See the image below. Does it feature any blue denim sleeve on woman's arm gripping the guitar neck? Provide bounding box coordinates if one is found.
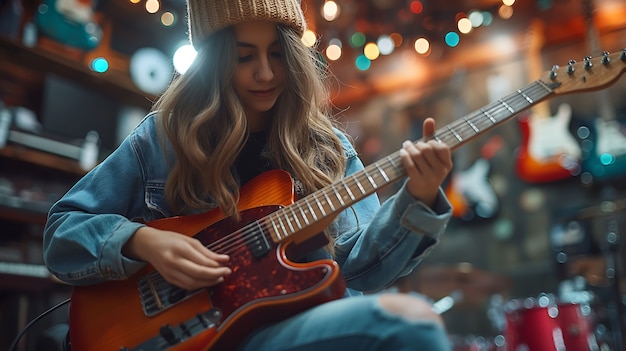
[332,134,452,291]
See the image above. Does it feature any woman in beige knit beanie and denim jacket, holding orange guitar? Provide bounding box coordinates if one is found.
[44,0,452,351]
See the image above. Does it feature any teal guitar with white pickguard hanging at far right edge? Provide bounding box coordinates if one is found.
[577,0,626,185]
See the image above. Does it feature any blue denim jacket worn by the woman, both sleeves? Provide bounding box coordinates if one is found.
[44,113,452,294]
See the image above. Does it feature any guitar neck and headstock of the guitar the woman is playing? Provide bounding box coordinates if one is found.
[255,48,626,243]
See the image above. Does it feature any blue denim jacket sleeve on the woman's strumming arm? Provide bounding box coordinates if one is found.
[43,115,159,285]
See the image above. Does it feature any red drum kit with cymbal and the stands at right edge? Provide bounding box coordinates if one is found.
[400,200,626,351]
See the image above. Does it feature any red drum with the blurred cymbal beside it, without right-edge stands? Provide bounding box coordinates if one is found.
[410,263,608,351]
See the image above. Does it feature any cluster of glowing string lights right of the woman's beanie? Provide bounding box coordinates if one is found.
[303,0,515,71]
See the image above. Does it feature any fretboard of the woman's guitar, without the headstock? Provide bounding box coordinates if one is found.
[262,80,554,242]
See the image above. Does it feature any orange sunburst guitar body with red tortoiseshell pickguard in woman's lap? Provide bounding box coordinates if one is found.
[70,171,345,351]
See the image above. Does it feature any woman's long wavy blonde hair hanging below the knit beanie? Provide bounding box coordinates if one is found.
[154,25,345,220]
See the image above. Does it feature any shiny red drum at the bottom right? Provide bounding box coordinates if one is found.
[504,295,599,351]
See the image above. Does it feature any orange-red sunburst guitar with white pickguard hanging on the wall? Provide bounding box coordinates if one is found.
[516,20,581,183]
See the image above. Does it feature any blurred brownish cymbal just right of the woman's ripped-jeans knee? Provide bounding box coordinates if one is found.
[411,262,511,303]
